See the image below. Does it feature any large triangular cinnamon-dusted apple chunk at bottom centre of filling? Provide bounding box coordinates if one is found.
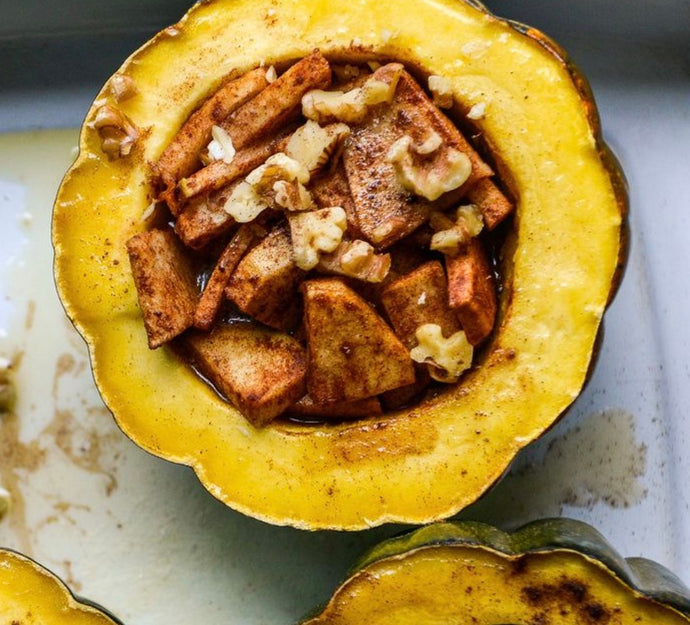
[302,278,415,403]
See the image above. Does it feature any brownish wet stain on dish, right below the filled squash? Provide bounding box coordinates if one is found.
[470,408,647,518]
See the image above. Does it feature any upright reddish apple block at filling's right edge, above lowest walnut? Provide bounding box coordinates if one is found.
[445,239,497,345]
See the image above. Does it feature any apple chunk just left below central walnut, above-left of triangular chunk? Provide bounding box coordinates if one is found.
[225,226,305,330]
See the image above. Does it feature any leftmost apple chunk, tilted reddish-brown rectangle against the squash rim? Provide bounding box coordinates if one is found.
[127,229,198,349]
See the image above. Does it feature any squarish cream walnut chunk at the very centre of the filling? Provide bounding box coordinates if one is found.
[288,206,347,271]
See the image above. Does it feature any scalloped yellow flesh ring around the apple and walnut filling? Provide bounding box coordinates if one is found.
[53,0,626,530]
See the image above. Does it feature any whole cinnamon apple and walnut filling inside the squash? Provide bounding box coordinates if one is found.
[127,51,512,426]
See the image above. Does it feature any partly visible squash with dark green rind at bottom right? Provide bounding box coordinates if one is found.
[303,519,690,625]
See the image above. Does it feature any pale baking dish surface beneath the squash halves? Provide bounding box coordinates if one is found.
[0,0,690,625]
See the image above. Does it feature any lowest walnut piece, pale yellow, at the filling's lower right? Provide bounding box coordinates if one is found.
[410,323,474,383]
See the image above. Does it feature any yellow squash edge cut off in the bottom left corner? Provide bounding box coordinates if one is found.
[0,549,120,625]
